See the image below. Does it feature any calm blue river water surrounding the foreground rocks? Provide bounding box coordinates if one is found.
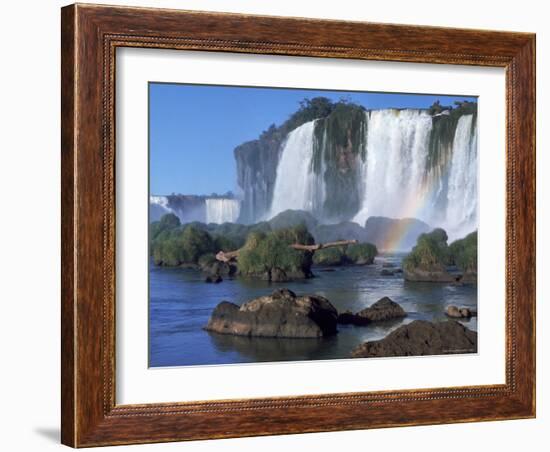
[149,254,477,367]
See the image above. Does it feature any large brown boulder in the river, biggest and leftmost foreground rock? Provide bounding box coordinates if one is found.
[205,289,338,338]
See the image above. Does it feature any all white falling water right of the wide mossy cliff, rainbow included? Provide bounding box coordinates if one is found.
[354,110,477,240]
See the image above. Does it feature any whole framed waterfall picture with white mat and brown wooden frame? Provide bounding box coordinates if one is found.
[61,4,535,447]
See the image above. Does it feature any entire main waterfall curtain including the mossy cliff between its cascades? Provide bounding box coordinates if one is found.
[256,109,478,240]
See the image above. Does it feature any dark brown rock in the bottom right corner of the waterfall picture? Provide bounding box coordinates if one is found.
[352,320,477,358]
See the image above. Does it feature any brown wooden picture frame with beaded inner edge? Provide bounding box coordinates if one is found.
[61,4,535,447]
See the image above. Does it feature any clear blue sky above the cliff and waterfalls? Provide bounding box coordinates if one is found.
[149,83,472,195]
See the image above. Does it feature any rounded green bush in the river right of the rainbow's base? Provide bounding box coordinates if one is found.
[403,228,449,271]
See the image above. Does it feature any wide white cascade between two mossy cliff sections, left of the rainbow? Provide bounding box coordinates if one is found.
[354,110,432,224]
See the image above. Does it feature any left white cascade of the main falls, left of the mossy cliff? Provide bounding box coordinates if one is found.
[268,121,322,218]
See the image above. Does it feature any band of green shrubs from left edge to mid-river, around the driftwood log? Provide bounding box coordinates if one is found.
[150,211,378,278]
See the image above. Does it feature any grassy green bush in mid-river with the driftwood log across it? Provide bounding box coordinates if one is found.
[239,226,314,277]
